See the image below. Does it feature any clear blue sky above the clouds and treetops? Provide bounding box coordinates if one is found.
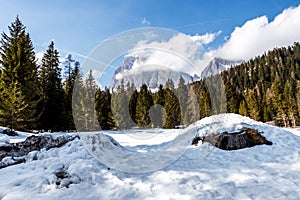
[0,0,300,59]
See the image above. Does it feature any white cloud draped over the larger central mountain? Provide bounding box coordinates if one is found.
[127,31,221,75]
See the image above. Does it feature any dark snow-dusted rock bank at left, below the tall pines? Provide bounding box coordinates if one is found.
[0,136,78,169]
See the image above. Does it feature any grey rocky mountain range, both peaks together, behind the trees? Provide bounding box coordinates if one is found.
[110,56,242,89]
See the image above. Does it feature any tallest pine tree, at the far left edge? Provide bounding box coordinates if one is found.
[0,17,41,130]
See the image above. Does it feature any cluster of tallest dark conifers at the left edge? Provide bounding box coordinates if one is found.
[0,17,79,131]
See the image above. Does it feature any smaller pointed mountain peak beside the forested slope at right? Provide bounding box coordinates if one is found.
[201,58,242,78]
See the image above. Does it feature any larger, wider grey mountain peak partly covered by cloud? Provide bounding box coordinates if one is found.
[110,56,199,89]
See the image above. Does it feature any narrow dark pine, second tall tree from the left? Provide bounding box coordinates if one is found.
[40,42,64,131]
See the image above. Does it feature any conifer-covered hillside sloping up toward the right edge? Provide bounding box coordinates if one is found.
[194,43,300,126]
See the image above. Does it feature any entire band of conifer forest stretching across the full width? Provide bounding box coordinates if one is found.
[0,17,300,131]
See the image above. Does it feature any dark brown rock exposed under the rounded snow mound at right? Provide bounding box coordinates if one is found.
[192,128,272,150]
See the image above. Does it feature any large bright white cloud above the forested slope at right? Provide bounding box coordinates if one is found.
[209,5,300,60]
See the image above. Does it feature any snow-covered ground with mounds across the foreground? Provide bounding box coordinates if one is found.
[0,114,300,200]
